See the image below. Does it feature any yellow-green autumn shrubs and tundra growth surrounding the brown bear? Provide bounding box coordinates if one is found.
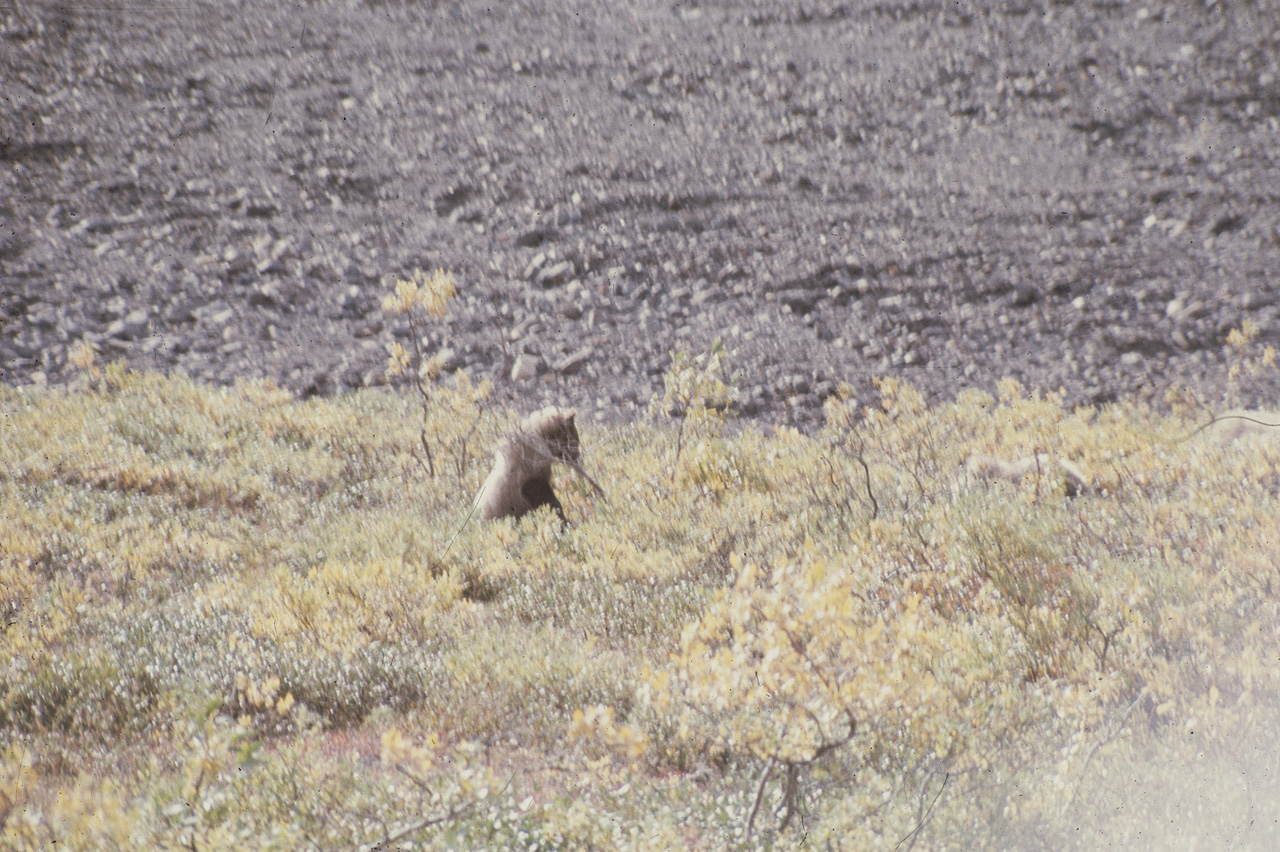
[0,281,1280,851]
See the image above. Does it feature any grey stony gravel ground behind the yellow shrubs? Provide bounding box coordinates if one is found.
[0,0,1280,429]
